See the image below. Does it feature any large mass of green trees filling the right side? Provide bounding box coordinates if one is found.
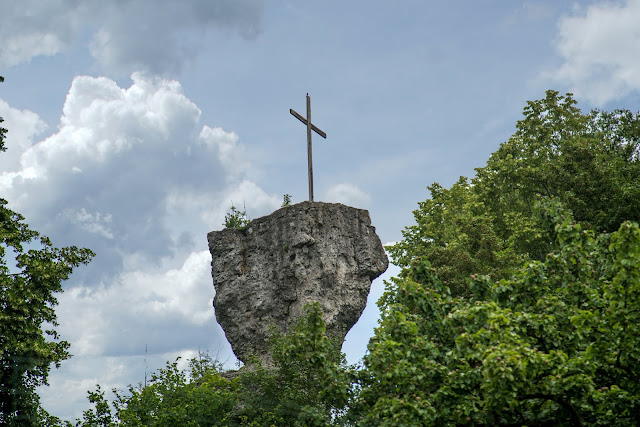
[358,91,640,425]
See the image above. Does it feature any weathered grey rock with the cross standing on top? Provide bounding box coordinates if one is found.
[207,202,389,362]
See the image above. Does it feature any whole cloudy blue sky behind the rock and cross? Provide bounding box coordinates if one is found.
[0,0,640,419]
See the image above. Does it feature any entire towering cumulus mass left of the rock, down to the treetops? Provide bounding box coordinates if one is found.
[0,73,280,415]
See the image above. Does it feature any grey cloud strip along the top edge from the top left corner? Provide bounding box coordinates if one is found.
[0,0,264,73]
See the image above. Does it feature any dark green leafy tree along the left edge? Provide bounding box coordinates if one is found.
[0,78,93,425]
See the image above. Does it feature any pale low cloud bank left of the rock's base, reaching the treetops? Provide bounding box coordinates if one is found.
[39,251,237,419]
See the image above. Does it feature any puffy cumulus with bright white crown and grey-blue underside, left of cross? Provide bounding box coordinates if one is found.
[0,73,279,281]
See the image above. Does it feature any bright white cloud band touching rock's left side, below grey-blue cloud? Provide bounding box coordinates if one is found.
[57,250,216,356]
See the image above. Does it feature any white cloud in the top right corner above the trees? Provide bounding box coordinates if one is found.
[544,0,640,105]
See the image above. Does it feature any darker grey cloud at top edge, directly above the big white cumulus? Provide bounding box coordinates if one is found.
[91,0,263,72]
